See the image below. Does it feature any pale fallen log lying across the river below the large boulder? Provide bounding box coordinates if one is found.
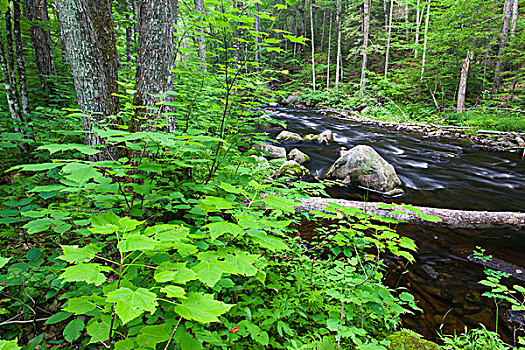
[295,197,525,230]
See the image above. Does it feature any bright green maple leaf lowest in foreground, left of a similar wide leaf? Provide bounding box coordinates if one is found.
[106,287,157,324]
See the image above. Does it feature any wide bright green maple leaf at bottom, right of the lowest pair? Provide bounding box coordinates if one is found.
[175,293,233,323]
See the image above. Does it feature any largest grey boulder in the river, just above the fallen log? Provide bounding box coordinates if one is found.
[323,145,402,195]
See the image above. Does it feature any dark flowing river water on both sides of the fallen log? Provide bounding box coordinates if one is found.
[267,108,525,342]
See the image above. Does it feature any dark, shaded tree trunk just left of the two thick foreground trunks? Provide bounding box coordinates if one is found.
[26,0,57,92]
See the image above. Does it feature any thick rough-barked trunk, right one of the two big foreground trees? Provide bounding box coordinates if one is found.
[134,0,175,131]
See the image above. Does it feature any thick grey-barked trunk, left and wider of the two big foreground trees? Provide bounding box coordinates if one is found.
[55,0,119,153]
